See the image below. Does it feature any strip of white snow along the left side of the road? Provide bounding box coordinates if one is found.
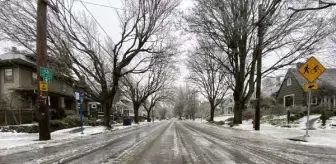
[0,122,158,149]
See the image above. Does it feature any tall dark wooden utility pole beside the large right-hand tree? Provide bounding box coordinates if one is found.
[254,5,266,130]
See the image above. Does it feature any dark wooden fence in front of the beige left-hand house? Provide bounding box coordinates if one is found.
[0,109,35,125]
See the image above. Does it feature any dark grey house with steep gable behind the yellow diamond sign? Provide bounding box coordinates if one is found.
[276,63,336,109]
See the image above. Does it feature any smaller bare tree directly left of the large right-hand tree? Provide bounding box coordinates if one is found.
[187,47,230,121]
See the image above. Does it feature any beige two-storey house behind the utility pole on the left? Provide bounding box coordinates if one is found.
[0,49,76,110]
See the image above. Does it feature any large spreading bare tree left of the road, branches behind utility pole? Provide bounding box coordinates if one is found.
[0,0,180,127]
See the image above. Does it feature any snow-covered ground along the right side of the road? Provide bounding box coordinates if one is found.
[225,115,336,147]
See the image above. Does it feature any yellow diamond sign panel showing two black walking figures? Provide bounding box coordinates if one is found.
[299,56,326,82]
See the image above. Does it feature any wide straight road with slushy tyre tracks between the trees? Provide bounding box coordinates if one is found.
[0,120,336,164]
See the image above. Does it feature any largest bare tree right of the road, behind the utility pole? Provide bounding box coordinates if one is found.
[186,0,331,124]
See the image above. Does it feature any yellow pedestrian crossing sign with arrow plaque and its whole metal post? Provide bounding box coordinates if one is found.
[299,56,326,137]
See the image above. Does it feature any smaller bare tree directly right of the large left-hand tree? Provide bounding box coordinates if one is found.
[122,60,175,123]
